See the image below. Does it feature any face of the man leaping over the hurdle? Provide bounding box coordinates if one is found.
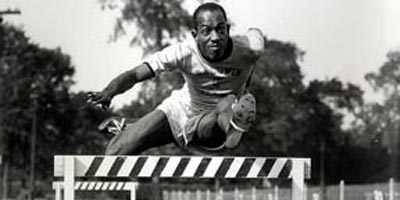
[193,10,229,62]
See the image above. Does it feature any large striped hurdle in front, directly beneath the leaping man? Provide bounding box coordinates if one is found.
[54,155,311,200]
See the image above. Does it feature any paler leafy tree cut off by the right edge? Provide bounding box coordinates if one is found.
[361,50,400,178]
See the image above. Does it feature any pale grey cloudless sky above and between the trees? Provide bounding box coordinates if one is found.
[0,0,400,107]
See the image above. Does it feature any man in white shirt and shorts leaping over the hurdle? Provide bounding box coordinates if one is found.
[88,3,264,155]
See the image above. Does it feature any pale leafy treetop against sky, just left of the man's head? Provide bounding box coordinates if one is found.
[100,0,191,53]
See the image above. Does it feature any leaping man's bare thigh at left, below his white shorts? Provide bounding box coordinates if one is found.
[106,110,173,155]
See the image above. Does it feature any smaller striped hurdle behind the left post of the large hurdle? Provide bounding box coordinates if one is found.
[53,181,137,200]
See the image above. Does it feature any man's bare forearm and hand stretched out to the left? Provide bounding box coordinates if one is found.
[87,63,155,109]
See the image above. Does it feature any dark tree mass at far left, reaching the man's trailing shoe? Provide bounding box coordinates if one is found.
[0,24,109,198]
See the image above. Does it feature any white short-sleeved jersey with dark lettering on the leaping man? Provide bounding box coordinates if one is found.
[144,29,264,114]
